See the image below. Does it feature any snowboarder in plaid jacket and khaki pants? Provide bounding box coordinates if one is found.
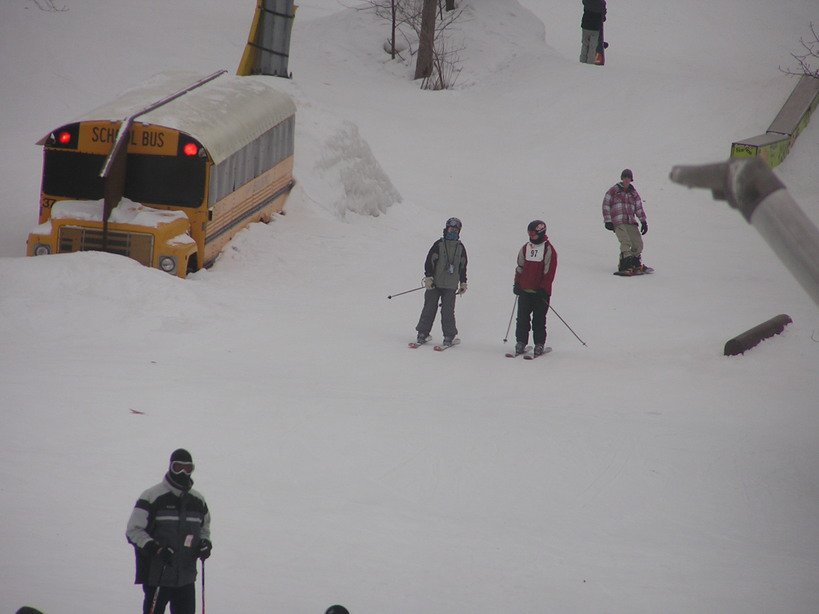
[603,168,649,274]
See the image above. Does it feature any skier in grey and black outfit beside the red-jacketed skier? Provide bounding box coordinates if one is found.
[415,217,466,347]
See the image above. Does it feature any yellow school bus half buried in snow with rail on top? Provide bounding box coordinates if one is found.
[27,71,296,277]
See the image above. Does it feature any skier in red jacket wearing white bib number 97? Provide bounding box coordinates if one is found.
[512,220,557,356]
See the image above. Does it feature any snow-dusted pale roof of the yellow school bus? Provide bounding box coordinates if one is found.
[37,71,296,164]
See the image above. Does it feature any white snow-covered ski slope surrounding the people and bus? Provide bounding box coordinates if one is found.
[0,0,819,614]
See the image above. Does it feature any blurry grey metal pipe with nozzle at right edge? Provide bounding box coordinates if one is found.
[670,158,819,307]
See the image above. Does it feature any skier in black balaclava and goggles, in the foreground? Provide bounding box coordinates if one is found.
[125,448,213,614]
